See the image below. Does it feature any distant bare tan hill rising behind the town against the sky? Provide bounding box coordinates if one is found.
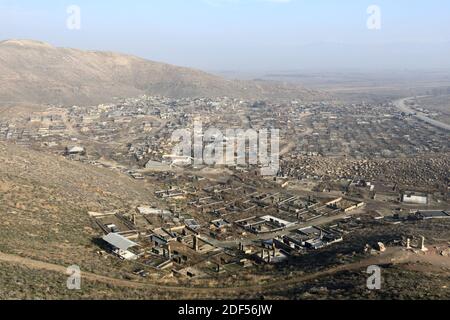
[0,40,313,104]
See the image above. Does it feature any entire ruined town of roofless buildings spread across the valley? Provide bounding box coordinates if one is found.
[0,96,450,279]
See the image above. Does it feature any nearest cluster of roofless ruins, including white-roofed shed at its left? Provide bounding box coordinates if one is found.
[89,171,450,279]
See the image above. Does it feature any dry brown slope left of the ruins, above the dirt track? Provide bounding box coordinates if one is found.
[0,143,156,268]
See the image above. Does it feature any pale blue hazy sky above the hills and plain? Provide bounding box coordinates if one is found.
[0,0,450,72]
